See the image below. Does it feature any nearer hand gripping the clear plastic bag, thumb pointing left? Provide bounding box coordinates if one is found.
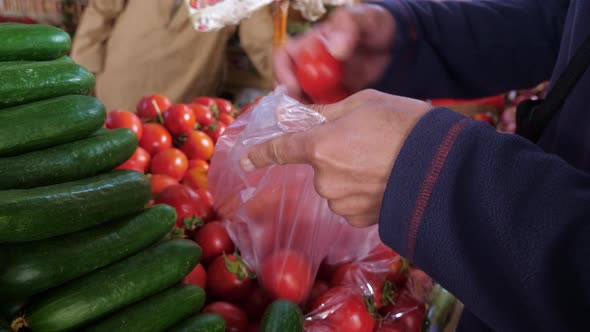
[240,90,432,227]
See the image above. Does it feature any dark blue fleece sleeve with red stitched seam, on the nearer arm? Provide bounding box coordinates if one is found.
[379,108,590,331]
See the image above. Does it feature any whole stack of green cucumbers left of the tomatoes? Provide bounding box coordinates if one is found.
[0,23,225,332]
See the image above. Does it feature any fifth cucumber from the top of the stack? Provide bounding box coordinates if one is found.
[0,170,151,243]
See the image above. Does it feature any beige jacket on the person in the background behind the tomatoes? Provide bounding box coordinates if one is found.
[72,0,272,111]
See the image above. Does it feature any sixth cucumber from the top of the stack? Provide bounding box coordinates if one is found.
[0,205,176,296]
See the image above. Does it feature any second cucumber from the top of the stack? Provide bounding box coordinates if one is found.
[0,61,95,108]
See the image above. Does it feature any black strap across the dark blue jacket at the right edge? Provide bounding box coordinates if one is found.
[516,35,590,142]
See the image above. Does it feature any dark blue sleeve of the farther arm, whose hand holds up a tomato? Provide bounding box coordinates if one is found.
[374,0,569,99]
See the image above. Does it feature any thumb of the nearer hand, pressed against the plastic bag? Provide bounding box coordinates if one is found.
[240,131,310,172]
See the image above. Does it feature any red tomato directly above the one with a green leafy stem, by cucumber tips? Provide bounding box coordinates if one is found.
[194,221,234,263]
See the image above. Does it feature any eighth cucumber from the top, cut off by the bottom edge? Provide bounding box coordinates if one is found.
[82,285,205,332]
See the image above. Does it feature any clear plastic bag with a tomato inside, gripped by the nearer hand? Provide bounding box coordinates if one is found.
[209,88,366,303]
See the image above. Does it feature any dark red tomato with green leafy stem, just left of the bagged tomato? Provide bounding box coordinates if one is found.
[207,254,254,303]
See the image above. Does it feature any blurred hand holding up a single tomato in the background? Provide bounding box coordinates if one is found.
[273,4,395,102]
